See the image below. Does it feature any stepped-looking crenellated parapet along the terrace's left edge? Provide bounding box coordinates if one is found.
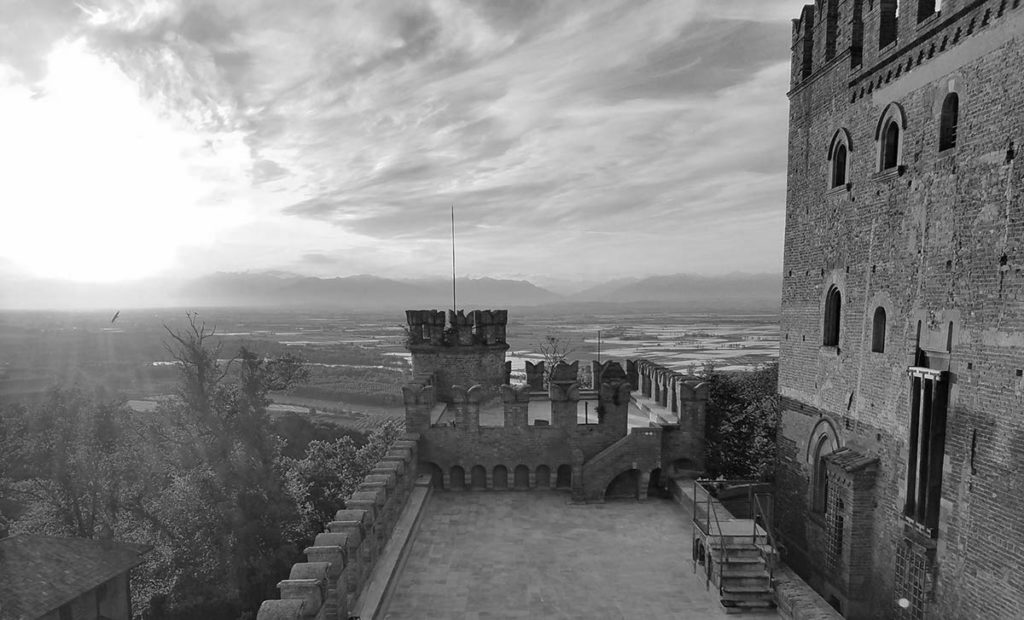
[257,433,428,620]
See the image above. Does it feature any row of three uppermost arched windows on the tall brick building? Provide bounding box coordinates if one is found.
[828,92,959,188]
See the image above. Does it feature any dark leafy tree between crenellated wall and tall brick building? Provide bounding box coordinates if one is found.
[702,362,779,481]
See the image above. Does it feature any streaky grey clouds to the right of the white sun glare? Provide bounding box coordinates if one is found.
[0,0,803,275]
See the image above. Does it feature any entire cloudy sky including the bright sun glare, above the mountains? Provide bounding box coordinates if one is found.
[0,0,805,283]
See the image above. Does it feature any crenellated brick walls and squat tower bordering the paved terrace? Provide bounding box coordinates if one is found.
[258,311,737,620]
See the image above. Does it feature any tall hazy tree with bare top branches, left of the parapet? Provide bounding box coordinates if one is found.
[132,315,304,617]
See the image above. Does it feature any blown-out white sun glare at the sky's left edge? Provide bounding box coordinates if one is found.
[0,41,237,282]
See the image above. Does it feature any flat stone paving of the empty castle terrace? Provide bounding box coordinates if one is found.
[380,491,775,620]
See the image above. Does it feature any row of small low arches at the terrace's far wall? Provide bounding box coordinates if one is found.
[419,463,572,491]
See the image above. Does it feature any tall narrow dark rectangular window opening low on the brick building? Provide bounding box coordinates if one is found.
[903,366,948,538]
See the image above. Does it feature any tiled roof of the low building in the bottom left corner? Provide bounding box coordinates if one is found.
[0,535,153,620]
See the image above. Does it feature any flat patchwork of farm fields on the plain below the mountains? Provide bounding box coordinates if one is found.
[0,307,778,429]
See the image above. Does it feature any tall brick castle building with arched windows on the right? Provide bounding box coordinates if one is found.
[776,0,1024,619]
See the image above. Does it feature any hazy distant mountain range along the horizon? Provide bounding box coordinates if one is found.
[0,273,781,309]
